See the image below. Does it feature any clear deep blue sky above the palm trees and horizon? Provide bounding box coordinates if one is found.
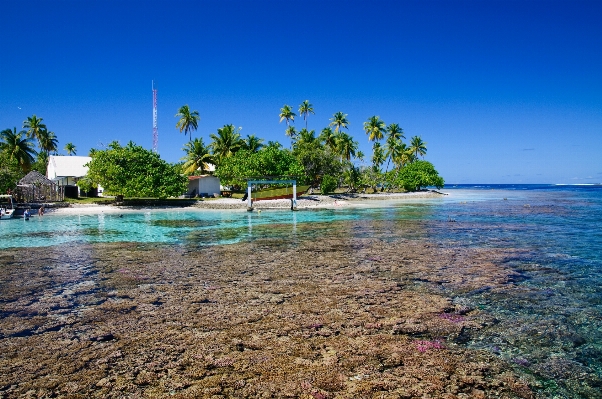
[0,0,602,183]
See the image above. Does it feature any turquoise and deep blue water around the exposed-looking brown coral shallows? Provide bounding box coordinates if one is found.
[0,184,602,398]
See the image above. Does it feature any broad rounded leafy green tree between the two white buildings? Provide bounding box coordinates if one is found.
[87,141,187,198]
